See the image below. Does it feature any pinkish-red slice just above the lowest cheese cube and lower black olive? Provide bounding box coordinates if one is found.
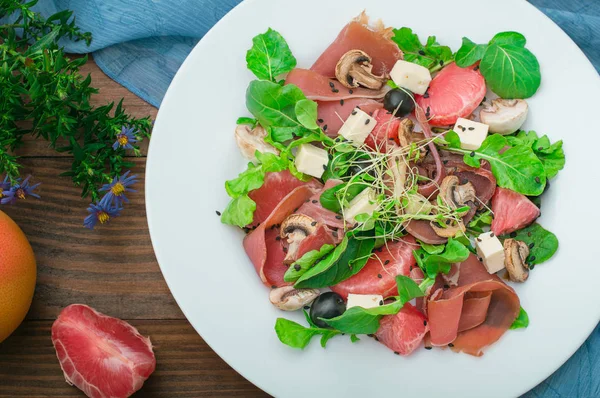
[331,236,417,298]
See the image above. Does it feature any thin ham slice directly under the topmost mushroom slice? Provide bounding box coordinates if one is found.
[285,68,390,102]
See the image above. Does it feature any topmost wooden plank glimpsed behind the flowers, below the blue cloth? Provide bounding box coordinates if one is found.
[15,54,158,157]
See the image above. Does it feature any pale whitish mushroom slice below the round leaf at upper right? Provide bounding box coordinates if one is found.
[479,98,529,135]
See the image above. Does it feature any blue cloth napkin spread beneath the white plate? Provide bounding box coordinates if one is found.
[31,0,600,398]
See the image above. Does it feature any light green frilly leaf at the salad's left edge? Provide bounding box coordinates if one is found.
[221,151,290,228]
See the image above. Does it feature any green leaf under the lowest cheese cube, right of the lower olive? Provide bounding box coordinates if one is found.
[321,275,424,334]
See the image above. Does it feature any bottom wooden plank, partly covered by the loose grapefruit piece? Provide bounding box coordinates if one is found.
[0,320,268,397]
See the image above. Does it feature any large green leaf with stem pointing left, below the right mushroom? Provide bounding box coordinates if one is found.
[448,134,546,196]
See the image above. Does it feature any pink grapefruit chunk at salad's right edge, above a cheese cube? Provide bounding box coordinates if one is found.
[492,187,540,236]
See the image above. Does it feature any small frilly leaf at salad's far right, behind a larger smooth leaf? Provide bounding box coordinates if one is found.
[506,131,565,178]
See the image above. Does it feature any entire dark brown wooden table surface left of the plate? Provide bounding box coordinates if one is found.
[0,60,266,397]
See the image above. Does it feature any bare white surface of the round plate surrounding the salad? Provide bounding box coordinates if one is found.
[146,0,600,397]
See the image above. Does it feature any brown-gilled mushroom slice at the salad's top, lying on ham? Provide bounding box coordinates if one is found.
[335,50,388,90]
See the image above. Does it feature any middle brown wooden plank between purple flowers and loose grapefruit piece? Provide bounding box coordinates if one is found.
[2,158,184,319]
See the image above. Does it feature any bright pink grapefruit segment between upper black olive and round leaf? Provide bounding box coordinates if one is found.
[415,63,486,127]
